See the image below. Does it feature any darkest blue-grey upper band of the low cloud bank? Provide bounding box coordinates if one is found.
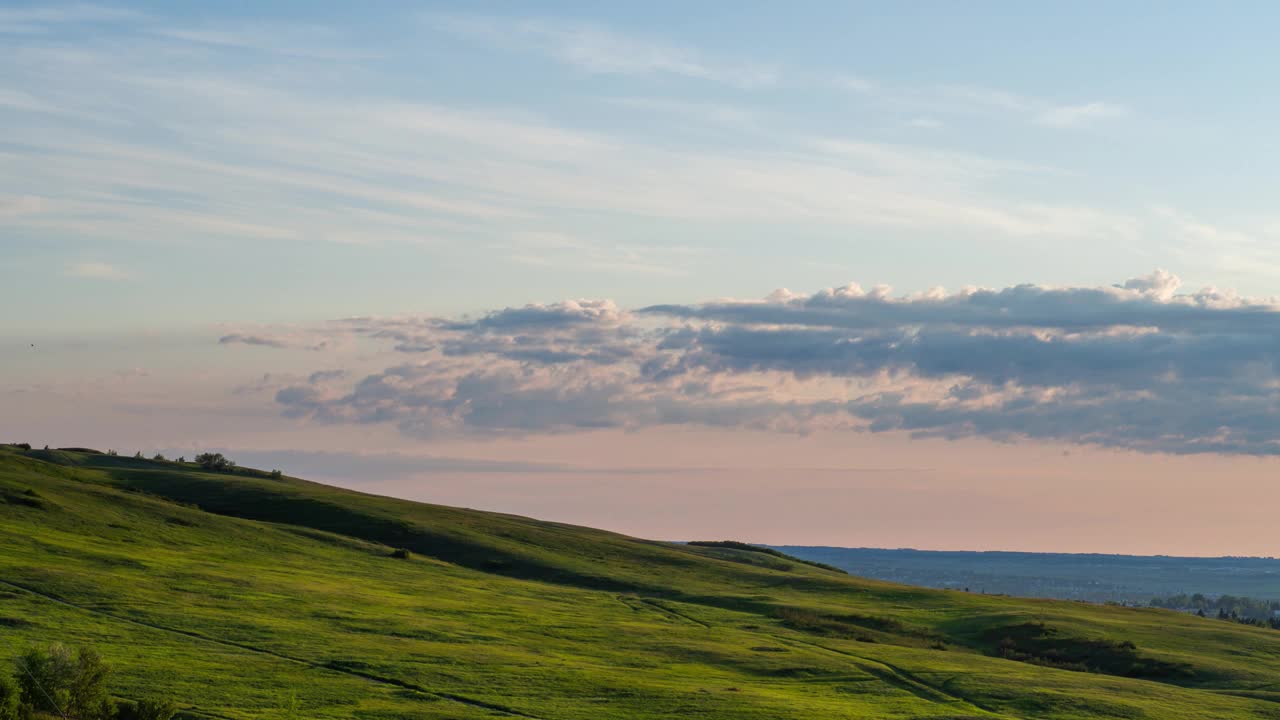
[648,320,1280,389]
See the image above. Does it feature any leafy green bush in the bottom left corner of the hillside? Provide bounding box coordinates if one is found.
[17,644,114,720]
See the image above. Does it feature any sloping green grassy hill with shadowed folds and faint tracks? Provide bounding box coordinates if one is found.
[0,446,1280,720]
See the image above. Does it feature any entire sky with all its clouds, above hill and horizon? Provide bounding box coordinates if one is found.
[0,1,1280,555]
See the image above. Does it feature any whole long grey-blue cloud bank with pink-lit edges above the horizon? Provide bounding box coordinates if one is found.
[264,270,1280,455]
